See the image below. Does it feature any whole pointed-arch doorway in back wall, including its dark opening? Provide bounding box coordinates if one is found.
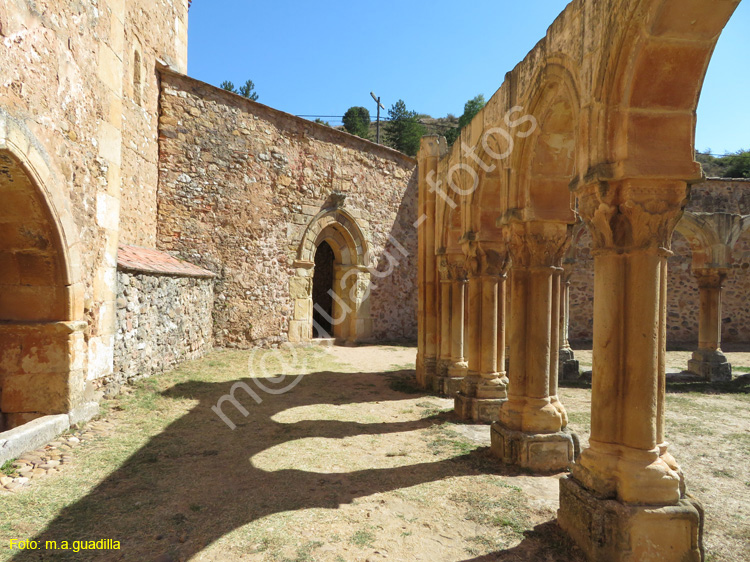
[289,207,372,344]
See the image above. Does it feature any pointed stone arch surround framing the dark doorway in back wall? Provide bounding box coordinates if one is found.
[289,207,373,343]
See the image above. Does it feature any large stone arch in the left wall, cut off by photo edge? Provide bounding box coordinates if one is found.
[0,120,86,428]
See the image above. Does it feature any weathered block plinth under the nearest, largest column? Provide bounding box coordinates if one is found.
[557,476,703,562]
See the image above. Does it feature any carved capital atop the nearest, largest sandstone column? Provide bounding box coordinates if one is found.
[576,178,687,252]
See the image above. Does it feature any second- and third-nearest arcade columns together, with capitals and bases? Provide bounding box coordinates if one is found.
[455,221,575,472]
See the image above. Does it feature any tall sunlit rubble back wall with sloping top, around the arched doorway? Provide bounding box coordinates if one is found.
[158,72,417,346]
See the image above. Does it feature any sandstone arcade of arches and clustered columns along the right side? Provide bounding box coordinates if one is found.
[417,0,743,562]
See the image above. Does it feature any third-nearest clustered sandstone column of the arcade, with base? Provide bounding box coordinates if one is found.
[455,235,508,422]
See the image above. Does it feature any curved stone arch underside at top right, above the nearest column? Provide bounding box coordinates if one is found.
[590,0,740,180]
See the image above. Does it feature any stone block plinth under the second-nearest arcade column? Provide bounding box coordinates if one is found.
[490,423,580,474]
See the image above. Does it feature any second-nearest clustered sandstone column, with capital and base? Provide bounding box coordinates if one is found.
[491,221,574,472]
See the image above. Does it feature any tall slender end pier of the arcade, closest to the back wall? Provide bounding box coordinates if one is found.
[417,135,444,388]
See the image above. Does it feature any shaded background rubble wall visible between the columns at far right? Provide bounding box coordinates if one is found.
[570,179,750,349]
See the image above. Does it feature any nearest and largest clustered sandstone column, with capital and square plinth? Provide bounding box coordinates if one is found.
[558,180,701,561]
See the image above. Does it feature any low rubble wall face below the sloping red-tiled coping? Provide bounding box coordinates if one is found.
[112,271,214,384]
